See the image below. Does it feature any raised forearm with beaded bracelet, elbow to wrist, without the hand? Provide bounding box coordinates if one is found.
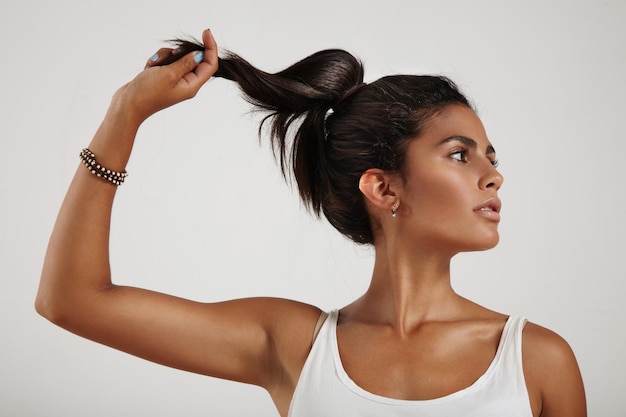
[36,99,139,322]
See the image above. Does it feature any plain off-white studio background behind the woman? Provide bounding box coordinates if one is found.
[0,0,626,417]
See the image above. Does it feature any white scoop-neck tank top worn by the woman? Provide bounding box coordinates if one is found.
[289,310,532,417]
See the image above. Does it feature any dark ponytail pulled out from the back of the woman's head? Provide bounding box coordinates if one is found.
[216,49,363,215]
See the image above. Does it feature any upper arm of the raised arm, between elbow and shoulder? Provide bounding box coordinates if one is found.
[45,286,319,387]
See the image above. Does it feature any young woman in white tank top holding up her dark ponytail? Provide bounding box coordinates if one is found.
[36,30,586,417]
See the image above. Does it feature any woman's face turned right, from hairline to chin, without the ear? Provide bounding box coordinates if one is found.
[398,105,503,254]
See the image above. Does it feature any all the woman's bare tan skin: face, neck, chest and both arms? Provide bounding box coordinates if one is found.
[36,31,586,417]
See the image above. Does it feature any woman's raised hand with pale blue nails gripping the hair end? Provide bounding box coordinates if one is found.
[113,29,218,125]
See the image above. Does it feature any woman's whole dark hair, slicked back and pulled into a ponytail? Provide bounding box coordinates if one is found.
[162,40,471,243]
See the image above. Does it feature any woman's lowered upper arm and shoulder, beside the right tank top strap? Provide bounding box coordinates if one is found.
[522,323,587,417]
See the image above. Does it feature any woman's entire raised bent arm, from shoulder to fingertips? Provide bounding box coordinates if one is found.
[36,30,319,404]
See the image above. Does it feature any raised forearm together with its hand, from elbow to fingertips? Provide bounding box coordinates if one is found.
[36,30,218,333]
